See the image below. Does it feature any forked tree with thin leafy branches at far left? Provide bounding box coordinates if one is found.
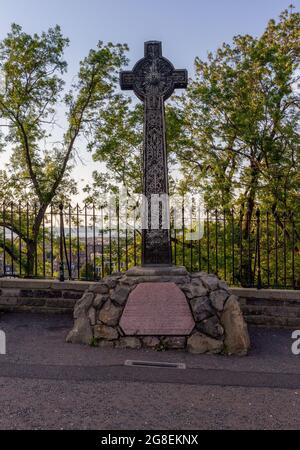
[0,24,127,275]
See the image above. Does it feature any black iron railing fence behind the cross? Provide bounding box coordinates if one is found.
[0,200,300,289]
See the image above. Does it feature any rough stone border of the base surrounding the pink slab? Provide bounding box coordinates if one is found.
[67,268,250,355]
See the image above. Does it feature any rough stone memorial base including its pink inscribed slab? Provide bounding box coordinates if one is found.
[67,266,250,355]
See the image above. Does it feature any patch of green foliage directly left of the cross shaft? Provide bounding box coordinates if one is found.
[85,95,143,200]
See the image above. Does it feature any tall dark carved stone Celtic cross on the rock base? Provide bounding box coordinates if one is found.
[120,41,188,266]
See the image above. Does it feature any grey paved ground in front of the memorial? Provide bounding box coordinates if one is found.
[0,314,300,430]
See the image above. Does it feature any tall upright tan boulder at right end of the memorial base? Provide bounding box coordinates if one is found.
[221,295,250,356]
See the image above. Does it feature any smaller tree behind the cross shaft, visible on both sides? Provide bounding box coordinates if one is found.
[85,94,188,203]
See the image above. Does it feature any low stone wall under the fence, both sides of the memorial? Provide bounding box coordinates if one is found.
[0,278,300,329]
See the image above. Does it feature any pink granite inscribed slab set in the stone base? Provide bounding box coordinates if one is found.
[120,283,195,336]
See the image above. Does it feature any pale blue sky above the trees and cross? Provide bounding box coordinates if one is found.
[0,0,300,199]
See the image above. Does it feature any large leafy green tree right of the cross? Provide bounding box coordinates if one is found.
[177,7,300,221]
